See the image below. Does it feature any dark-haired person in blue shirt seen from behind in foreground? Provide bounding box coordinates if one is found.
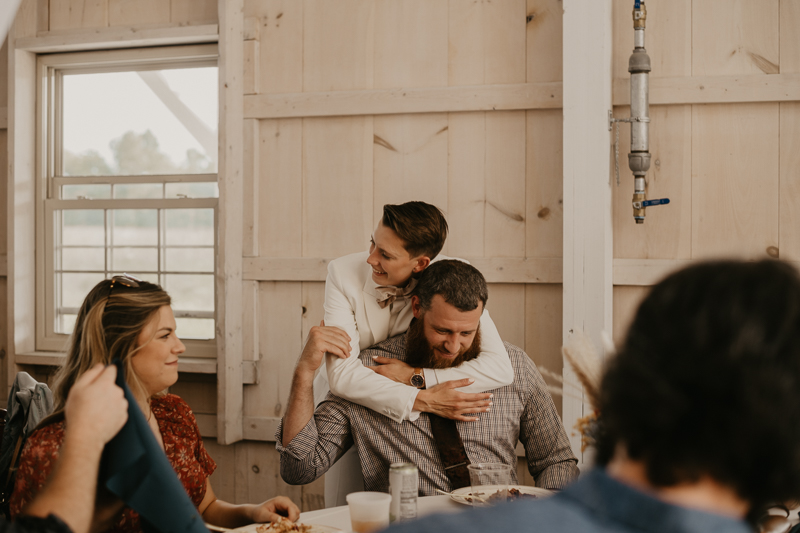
[391,261,800,533]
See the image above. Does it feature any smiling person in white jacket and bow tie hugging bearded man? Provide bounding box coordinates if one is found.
[314,202,514,505]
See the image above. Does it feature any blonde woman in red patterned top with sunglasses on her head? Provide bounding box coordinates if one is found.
[11,276,300,532]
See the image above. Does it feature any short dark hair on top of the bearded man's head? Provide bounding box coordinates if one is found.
[414,259,489,311]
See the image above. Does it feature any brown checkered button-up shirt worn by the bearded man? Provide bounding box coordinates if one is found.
[277,334,578,496]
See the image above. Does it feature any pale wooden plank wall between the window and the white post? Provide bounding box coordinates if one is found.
[244,0,562,490]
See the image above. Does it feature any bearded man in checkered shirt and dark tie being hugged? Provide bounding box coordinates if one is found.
[276,260,578,495]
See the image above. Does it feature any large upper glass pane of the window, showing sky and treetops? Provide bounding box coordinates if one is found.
[63,67,218,176]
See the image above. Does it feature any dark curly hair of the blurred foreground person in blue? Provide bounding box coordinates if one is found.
[597,260,800,506]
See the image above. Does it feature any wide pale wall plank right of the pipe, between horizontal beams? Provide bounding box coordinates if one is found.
[692,104,779,258]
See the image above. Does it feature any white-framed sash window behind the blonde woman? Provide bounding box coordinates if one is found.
[36,45,218,357]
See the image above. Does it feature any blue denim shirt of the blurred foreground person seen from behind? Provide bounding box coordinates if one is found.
[389,469,752,533]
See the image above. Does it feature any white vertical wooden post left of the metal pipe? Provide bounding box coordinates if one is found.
[562,0,612,458]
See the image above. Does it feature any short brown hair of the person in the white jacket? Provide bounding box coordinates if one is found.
[381,202,447,259]
